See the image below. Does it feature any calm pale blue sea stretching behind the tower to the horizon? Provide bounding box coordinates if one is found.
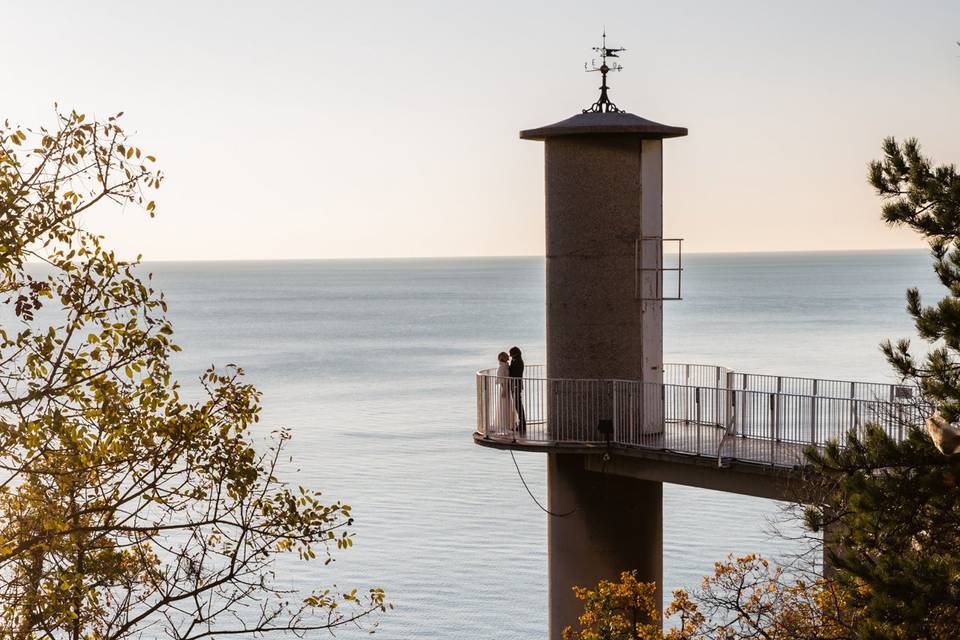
[150,251,936,640]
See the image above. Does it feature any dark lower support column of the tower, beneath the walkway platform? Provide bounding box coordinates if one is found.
[547,453,663,640]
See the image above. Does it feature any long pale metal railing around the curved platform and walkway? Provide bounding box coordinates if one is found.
[477,364,929,467]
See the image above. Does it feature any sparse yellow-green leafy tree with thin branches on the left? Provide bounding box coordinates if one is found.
[0,107,388,640]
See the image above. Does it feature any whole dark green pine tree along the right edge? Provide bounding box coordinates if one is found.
[807,138,960,639]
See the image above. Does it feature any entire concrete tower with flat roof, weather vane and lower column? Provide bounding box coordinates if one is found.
[520,42,687,640]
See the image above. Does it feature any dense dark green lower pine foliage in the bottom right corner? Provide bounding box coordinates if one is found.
[807,426,960,640]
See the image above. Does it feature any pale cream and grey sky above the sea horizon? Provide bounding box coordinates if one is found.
[0,0,960,260]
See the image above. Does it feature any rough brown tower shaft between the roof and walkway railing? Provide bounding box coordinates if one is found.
[545,134,663,382]
